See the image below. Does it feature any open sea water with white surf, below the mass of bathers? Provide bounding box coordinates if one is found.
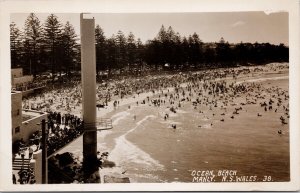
[57,78,290,183]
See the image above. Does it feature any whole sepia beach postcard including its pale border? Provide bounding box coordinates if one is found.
[1,1,299,190]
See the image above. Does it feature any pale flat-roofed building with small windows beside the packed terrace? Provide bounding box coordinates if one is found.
[11,91,47,142]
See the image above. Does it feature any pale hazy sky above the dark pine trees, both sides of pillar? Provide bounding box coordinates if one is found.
[11,12,289,46]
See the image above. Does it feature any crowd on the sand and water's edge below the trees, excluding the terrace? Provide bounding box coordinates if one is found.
[23,63,288,130]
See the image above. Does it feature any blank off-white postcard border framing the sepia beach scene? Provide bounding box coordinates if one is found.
[0,0,300,191]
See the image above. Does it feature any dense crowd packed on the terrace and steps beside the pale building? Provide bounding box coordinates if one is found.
[13,112,83,184]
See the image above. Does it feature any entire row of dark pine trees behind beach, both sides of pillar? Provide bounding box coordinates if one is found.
[10,13,289,77]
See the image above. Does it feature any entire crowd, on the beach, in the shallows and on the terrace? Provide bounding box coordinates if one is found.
[12,64,289,183]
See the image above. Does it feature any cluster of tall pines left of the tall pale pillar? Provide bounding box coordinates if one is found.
[10,13,80,77]
